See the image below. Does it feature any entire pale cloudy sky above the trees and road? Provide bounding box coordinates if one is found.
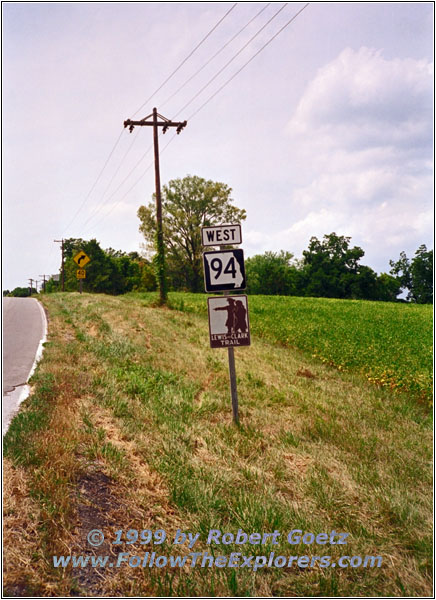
[2,2,434,290]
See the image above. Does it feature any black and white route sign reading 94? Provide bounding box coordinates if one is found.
[203,248,246,292]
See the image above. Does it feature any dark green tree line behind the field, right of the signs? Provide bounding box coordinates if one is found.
[245,238,433,304]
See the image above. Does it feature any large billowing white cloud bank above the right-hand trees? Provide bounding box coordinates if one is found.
[279,48,433,264]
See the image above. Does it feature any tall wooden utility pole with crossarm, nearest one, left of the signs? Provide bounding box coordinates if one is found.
[124,108,188,306]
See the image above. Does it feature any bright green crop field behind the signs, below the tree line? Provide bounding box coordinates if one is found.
[152,293,433,402]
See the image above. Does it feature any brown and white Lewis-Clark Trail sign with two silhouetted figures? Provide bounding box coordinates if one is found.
[207,295,250,348]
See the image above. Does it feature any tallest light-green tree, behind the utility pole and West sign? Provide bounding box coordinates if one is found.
[138,175,246,292]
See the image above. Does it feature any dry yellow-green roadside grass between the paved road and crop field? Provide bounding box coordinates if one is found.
[4,294,432,597]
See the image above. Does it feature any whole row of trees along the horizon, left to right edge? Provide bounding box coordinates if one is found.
[4,175,433,304]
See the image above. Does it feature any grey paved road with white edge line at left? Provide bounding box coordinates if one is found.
[2,298,47,435]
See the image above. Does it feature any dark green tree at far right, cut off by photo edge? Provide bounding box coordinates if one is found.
[389,244,433,304]
